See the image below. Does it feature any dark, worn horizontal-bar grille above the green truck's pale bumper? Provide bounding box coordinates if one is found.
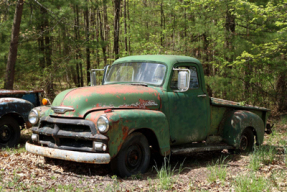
[32,116,108,152]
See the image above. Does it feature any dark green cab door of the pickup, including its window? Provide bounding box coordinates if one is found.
[168,64,210,145]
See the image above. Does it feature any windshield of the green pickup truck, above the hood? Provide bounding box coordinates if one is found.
[105,63,166,85]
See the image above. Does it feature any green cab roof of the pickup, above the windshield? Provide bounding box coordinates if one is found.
[113,55,201,66]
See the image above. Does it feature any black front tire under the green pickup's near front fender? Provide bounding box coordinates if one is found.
[111,133,150,178]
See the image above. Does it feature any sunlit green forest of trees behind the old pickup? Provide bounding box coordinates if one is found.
[0,0,287,112]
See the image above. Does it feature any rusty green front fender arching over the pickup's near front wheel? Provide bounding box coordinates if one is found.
[86,110,170,157]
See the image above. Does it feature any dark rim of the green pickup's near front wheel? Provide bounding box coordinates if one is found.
[126,145,143,171]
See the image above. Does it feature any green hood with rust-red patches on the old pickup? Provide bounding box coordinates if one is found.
[50,84,161,118]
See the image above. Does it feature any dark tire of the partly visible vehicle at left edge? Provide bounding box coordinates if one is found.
[0,117,20,147]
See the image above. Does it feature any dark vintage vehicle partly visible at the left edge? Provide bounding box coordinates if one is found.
[0,89,43,148]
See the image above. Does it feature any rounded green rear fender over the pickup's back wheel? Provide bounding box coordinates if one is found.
[222,110,264,148]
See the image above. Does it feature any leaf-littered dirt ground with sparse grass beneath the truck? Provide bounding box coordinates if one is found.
[0,119,287,192]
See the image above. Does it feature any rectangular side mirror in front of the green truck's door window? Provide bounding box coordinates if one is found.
[173,68,190,92]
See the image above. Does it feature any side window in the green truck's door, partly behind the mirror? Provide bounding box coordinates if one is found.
[170,66,199,89]
